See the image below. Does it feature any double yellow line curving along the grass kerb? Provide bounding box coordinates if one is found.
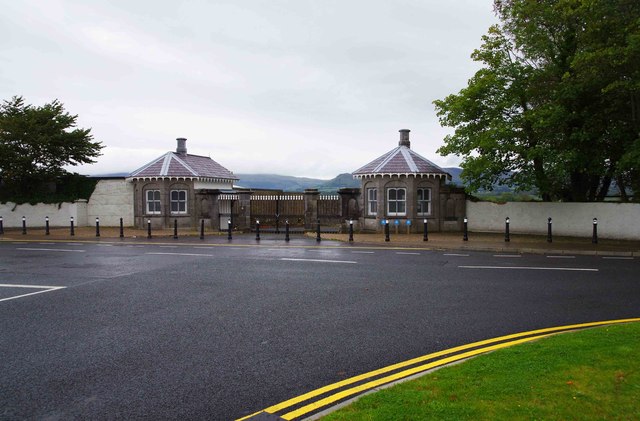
[237,318,640,421]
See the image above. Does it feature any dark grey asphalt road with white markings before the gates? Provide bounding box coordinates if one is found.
[0,239,640,420]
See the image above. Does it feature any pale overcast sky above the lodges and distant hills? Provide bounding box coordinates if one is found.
[0,0,497,179]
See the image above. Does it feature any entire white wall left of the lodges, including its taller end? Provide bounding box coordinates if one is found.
[0,179,133,229]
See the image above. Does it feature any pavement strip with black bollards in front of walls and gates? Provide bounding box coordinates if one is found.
[0,223,640,257]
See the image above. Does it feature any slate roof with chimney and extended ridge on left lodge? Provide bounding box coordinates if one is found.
[128,138,238,182]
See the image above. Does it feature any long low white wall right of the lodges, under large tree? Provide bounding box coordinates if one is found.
[467,200,640,240]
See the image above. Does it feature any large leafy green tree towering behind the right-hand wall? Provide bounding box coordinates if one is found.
[434,0,640,201]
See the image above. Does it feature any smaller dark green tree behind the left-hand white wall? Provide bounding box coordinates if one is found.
[0,96,103,194]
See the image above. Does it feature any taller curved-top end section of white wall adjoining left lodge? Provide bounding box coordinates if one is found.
[87,179,133,227]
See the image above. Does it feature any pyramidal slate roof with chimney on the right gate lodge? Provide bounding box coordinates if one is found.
[353,129,451,180]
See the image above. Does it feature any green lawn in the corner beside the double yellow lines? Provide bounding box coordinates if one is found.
[323,323,640,421]
